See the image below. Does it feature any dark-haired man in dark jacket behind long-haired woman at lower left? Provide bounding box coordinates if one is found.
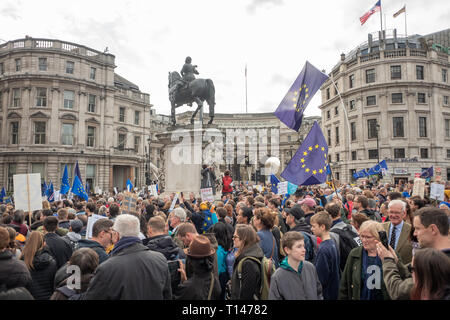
[44,217,72,268]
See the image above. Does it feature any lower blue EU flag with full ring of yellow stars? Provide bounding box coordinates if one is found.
[281,121,328,186]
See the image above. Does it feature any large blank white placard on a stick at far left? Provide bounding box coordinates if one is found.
[13,173,42,212]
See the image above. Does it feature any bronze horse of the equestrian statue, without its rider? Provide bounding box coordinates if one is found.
[169,71,216,125]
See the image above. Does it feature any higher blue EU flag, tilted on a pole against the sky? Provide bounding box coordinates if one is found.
[275,61,329,131]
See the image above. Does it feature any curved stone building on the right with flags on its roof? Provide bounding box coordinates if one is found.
[320,29,450,182]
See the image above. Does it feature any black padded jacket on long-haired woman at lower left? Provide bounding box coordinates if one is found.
[26,248,57,300]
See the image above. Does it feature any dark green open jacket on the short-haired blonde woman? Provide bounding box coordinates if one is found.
[338,246,390,300]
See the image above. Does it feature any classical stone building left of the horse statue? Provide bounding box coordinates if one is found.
[0,37,152,191]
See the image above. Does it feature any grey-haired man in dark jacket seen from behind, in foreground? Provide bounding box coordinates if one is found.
[84,214,172,300]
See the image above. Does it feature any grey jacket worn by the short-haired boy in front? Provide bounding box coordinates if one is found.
[269,261,323,300]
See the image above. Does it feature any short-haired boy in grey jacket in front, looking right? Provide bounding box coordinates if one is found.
[269,231,323,300]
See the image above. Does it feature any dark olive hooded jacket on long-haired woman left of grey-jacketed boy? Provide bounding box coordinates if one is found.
[231,243,264,300]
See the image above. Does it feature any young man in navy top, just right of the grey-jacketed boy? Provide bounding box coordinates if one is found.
[311,211,340,300]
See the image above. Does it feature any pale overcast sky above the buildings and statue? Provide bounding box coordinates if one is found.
[0,0,450,115]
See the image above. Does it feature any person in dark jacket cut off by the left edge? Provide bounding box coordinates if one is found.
[0,227,31,299]
